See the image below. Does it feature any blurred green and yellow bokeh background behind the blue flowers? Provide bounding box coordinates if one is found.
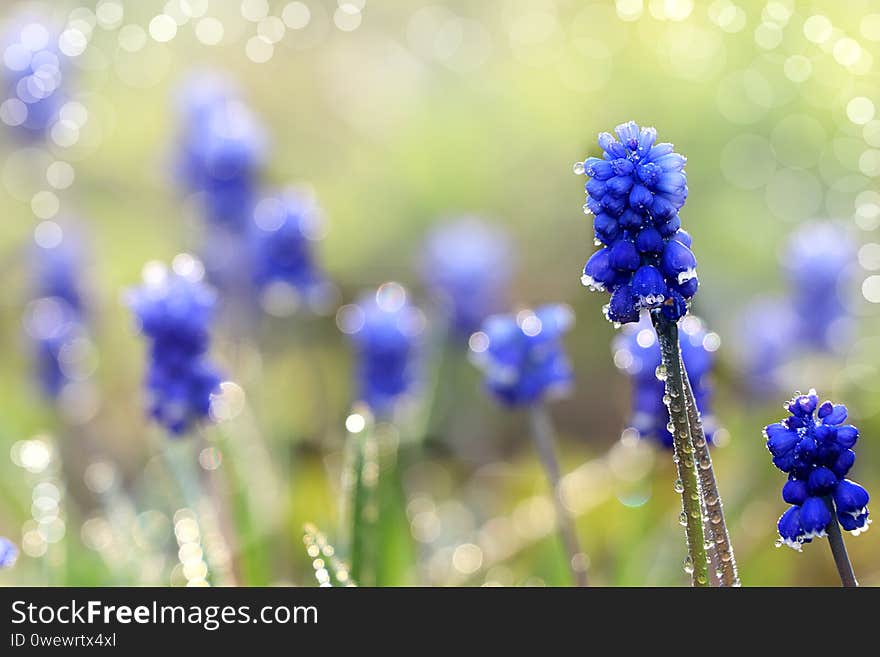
[0,0,880,586]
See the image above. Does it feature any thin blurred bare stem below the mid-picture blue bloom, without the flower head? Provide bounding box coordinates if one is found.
[529,403,588,586]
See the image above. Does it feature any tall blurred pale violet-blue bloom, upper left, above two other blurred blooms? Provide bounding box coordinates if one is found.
[176,74,267,231]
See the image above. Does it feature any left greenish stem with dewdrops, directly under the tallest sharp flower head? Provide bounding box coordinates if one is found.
[651,312,709,586]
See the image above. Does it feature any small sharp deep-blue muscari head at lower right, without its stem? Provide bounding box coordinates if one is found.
[764,390,871,551]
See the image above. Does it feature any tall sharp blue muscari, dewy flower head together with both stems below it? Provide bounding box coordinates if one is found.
[574,121,739,586]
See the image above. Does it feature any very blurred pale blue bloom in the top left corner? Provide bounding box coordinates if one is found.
[0,17,67,139]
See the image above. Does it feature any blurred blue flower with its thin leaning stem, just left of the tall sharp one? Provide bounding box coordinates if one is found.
[469,304,587,586]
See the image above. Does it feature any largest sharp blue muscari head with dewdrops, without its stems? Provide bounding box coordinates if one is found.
[574,121,698,324]
